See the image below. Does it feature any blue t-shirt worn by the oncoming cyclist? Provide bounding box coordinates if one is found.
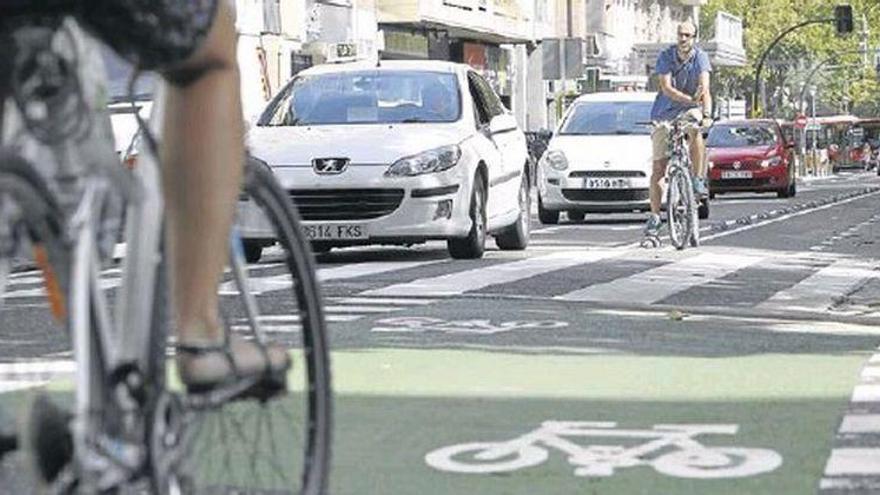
[651,45,712,120]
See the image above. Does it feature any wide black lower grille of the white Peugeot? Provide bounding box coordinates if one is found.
[290,189,404,220]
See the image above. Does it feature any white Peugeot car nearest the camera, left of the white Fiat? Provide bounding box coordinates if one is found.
[238,61,530,260]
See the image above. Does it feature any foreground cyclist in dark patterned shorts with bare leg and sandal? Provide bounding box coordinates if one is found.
[0,0,290,476]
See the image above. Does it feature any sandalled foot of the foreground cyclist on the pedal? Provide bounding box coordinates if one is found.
[177,336,291,395]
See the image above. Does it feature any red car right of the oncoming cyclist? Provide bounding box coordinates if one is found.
[706,119,797,198]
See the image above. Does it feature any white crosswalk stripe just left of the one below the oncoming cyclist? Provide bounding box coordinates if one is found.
[359,249,628,296]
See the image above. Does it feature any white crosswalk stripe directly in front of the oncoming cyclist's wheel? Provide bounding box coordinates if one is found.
[555,251,764,304]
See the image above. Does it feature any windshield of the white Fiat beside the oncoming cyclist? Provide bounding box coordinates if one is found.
[559,101,652,135]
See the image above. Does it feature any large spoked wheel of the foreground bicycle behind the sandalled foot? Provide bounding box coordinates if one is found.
[179,162,331,495]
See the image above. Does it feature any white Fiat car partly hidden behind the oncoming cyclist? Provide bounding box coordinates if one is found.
[538,92,656,224]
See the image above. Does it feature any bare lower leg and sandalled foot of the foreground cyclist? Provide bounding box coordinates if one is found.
[162,1,288,387]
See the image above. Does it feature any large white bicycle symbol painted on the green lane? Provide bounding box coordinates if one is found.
[425,421,782,479]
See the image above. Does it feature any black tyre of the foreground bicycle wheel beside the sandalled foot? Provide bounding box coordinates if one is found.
[239,160,333,495]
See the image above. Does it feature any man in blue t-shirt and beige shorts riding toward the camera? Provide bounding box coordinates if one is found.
[645,21,712,237]
